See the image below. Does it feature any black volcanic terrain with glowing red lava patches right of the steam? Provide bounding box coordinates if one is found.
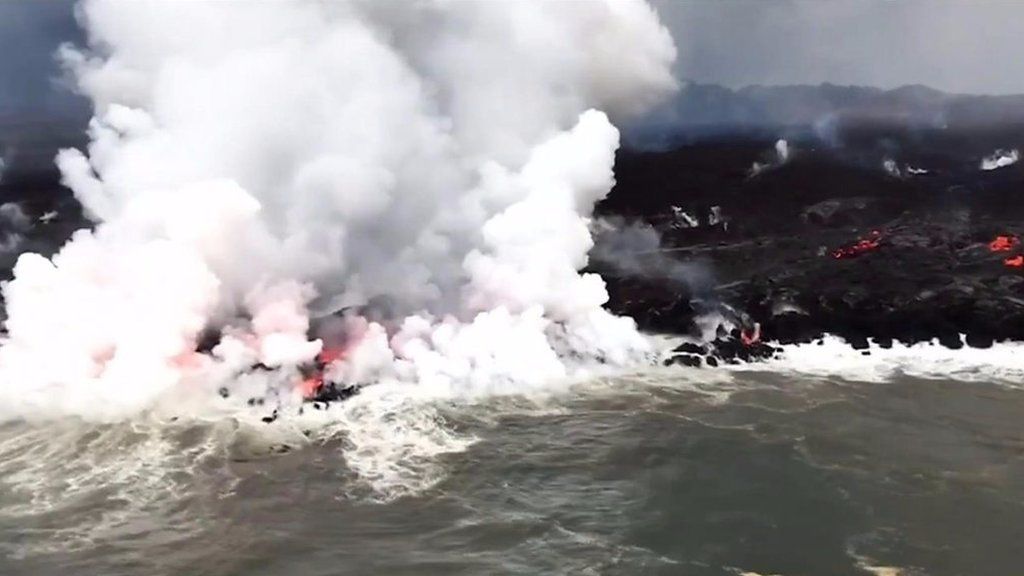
[592,118,1024,360]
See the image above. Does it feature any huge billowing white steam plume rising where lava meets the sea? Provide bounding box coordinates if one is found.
[0,0,675,418]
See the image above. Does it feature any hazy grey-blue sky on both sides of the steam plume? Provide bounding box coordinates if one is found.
[0,0,1024,114]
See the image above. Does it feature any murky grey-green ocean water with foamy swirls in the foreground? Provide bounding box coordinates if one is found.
[0,366,1024,576]
